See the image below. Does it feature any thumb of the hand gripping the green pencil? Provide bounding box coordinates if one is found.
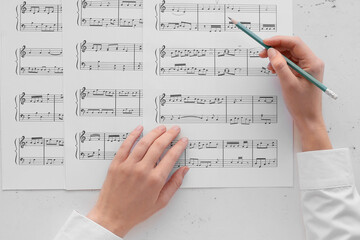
[268,48,293,80]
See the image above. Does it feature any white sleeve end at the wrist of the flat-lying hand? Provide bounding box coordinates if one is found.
[54,211,122,240]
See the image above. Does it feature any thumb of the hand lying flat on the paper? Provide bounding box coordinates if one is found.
[157,167,189,209]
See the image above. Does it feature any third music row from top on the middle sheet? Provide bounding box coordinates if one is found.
[76,87,143,118]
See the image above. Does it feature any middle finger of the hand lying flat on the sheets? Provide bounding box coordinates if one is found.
[143,126,180,168]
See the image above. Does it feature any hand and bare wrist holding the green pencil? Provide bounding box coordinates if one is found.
[260,36,332,151]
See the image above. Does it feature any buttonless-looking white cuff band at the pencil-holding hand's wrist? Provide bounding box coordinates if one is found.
[297,149,354,190]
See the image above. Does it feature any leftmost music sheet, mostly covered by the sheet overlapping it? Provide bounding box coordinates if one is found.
[1,0,65,190]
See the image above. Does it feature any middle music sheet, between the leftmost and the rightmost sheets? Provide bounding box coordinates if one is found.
[63,0,143,189]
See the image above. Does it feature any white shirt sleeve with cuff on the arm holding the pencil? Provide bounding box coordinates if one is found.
[298,149,360,240]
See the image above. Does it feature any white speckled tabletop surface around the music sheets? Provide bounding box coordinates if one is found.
[0,0,360,240]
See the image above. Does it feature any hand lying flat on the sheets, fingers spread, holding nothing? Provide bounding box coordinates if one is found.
[88,126,189,237]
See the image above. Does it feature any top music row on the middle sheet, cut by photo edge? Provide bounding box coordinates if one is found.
[78,0,143,28]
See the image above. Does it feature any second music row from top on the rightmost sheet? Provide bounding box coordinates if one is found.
[155,46,273,77]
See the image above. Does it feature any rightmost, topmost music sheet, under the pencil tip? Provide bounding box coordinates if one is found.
[144,0,293,188]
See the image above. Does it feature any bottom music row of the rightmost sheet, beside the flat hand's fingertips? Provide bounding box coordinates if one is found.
[173,140,278,168]
